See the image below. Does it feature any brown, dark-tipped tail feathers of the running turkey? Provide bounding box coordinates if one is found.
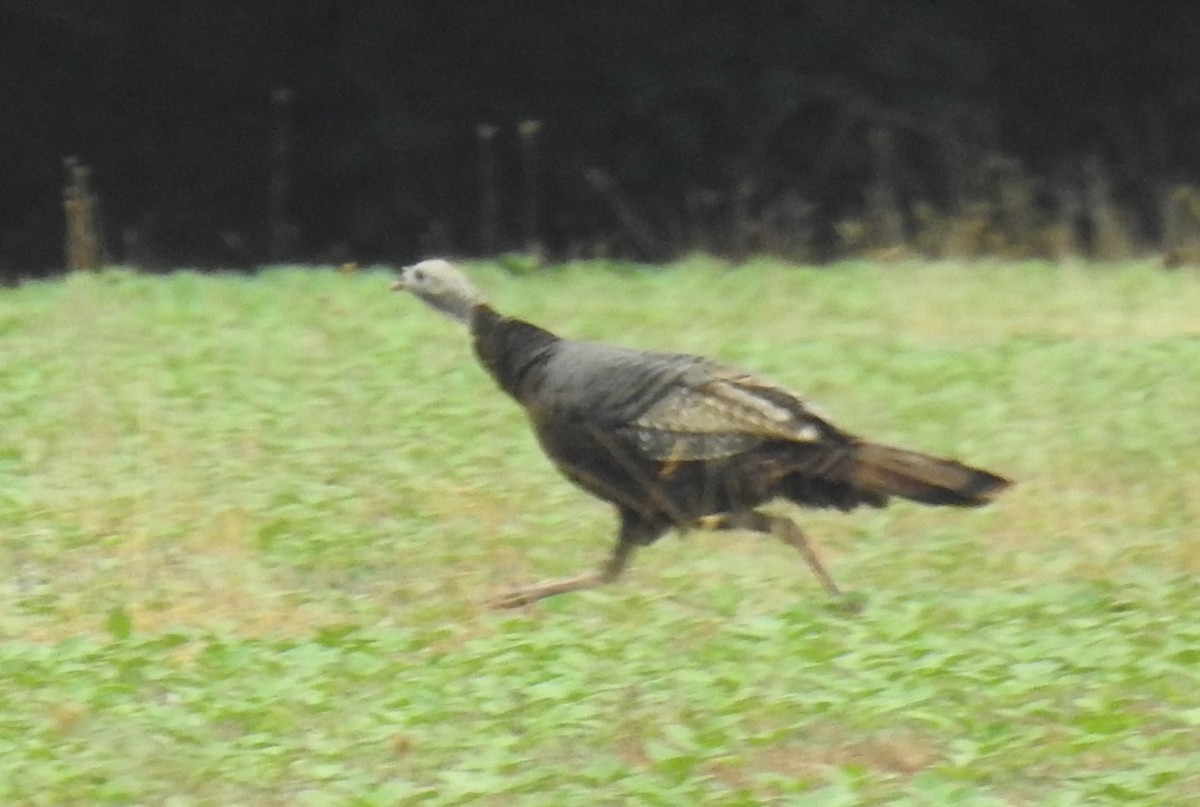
[850,443,1013,507]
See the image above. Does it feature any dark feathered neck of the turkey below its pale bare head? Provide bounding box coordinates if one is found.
[470,304,562,404]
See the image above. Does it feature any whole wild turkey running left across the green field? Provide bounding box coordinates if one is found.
[392,259,1010,608]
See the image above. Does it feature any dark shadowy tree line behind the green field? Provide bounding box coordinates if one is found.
[0,0,1200,274]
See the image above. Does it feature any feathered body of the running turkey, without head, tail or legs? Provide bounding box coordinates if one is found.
[473,306,887,544]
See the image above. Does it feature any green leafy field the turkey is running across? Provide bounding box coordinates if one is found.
[0,261,1200,807]
